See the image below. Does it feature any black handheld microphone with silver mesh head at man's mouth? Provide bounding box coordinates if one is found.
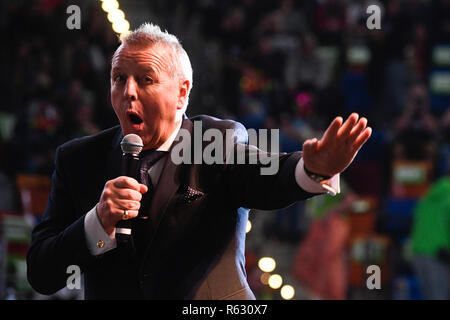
[116,133,144,243]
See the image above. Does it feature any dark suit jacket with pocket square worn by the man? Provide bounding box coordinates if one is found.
[27,116,313,299]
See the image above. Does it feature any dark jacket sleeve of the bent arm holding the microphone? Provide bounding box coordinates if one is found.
[27,146,95,294]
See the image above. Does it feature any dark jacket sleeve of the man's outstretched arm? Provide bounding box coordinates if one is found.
[216,122,316,210]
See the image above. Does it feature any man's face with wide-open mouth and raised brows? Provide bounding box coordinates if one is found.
[111,45,190,149]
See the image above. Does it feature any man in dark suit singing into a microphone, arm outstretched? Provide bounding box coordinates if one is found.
[27,24,371,299]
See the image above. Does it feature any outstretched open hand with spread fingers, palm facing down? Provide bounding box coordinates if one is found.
[303,113,372,176]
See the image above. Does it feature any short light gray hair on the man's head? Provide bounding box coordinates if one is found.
[120,22,193,104]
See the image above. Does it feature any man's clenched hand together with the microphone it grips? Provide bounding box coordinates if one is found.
[97,134,148,241]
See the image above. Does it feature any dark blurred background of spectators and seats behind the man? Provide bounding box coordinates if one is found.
[0,0,450,299]
